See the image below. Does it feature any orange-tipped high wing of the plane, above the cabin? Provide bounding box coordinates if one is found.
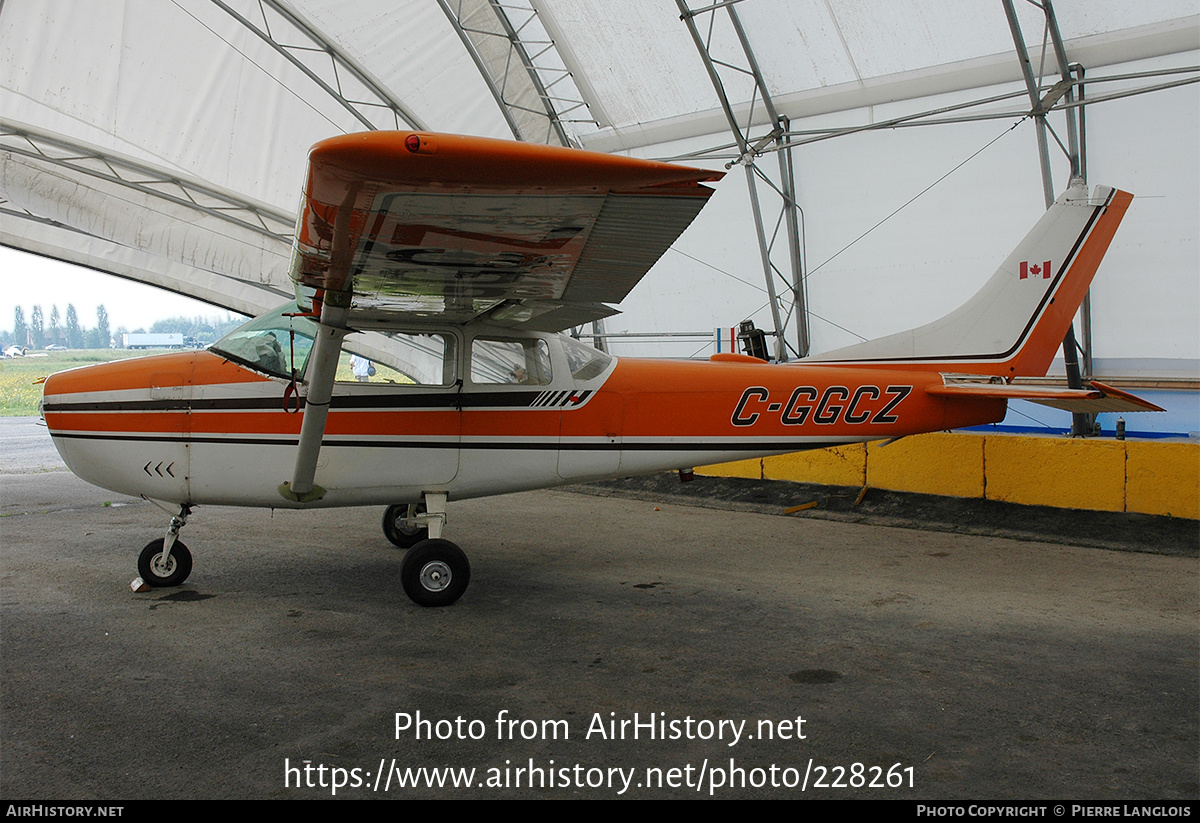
[290,132,724,331]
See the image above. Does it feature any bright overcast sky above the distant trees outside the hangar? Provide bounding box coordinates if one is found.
[0,247,239,332]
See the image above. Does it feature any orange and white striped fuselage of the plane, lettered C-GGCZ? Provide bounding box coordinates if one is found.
[43,335,1004,507]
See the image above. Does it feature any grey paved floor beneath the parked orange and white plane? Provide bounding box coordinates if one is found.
[0,421,1200,800]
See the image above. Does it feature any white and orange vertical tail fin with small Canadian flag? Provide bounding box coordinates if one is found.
[804,184,1133,377]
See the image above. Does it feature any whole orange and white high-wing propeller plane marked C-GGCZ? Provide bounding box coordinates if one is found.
[43,132,1154,606]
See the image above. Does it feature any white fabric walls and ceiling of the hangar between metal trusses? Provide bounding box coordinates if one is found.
[0,0,1200,380]
